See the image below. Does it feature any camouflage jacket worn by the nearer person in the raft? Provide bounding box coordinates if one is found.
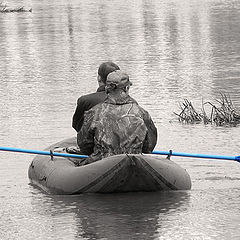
[77,91,157,163]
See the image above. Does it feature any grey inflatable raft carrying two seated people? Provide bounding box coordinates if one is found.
[28,138,191,194]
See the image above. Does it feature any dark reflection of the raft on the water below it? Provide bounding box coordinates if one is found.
[32,191,189,239]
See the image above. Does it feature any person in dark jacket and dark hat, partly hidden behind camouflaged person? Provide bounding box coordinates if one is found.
[72,62,119,132]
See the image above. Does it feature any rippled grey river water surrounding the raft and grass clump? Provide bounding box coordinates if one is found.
[0,0,240,240]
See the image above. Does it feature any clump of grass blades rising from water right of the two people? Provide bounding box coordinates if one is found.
[174,93,240,126]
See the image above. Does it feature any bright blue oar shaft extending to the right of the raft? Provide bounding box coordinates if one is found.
[152,151,240,162]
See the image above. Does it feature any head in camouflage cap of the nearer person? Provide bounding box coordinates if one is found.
[106,70,132,92]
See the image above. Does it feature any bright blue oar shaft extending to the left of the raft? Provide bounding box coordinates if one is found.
[0,147,88,158]
